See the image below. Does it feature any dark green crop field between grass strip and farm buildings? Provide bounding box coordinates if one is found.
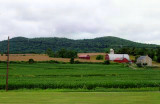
[0,63,160,90]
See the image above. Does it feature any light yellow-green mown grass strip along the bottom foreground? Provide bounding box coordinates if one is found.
[0,92,160,104]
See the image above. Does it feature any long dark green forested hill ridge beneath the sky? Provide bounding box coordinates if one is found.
[0,36,159,53]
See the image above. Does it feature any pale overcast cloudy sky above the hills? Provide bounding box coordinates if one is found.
[0,0,160,44]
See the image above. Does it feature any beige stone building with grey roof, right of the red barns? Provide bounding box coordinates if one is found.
[136,55,152,66]
